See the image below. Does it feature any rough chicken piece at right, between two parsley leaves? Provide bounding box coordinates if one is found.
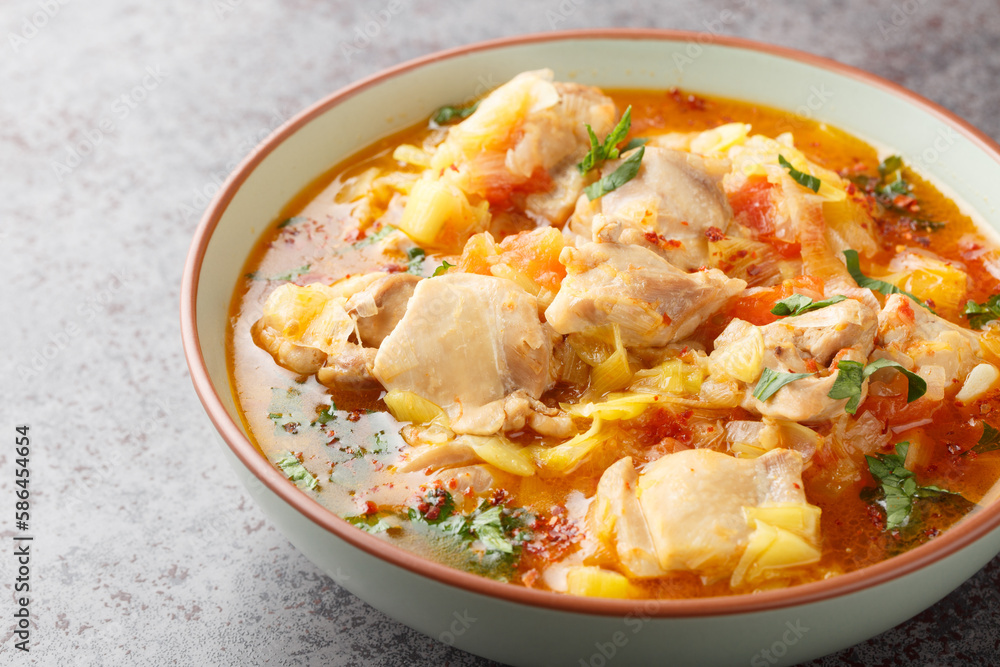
[740,299,878,423]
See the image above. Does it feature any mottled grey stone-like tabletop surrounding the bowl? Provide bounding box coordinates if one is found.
[0,0,1000,665]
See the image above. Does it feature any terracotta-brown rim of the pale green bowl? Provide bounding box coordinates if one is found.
[179,28,1000,618]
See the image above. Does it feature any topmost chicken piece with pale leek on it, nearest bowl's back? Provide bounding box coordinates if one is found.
[431,70,616,226]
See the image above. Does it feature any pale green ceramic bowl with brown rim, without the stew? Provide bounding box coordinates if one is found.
[181,30,1000,667]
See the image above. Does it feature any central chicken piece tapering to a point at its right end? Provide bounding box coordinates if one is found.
[545,243,746,347]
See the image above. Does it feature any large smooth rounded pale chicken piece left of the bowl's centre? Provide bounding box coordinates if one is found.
[373,273,555,435]
